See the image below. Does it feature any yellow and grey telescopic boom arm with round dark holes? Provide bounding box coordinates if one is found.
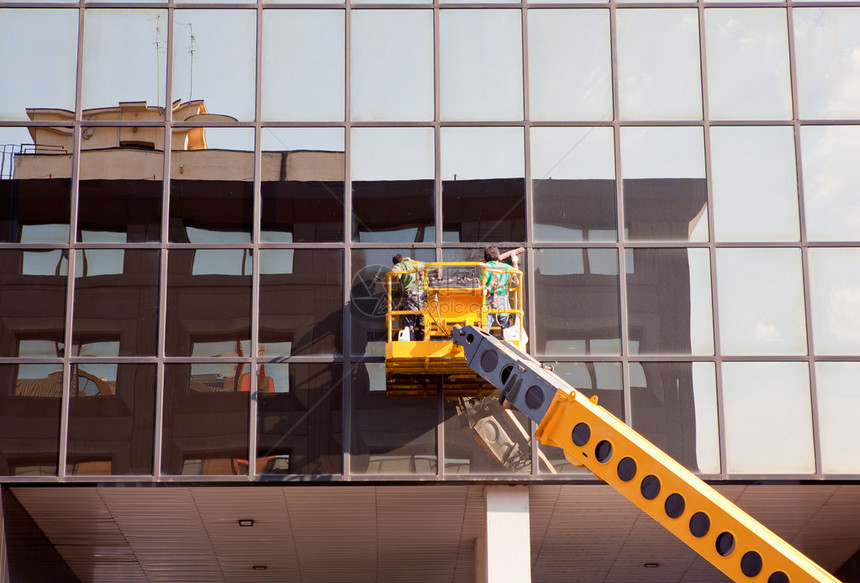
[453,326,838,583]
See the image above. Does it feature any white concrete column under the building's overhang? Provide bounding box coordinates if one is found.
[475,486,531,583]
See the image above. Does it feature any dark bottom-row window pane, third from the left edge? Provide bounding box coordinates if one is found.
[161,362,250,476]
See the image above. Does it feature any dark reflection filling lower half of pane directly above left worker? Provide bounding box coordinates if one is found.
[352,180,435,243]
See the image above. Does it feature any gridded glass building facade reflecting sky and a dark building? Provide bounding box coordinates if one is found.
[0,0,860,492]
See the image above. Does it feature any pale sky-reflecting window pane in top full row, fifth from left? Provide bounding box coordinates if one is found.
[351,10,433,121]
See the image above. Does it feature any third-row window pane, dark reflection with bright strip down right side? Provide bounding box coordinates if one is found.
[626,249,714,355]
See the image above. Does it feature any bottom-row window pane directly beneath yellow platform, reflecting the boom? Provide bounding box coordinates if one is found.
[444,396,532,475]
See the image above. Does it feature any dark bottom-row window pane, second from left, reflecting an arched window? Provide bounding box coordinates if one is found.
[66,364,155,475]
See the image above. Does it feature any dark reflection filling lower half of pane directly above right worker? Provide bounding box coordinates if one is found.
[442,178,526,242]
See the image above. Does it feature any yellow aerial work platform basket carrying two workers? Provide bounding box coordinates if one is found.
[385,261,528,397]
